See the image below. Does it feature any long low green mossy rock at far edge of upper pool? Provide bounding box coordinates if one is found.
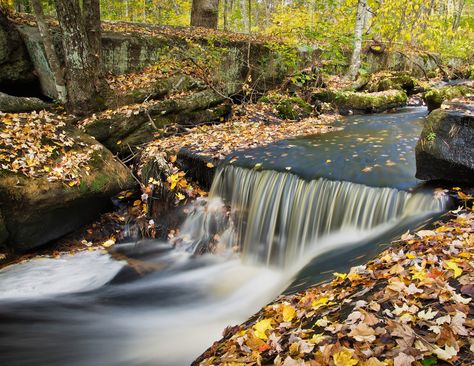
[333,90,408,114]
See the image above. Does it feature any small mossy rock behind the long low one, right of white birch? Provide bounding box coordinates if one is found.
[365,72,418,94]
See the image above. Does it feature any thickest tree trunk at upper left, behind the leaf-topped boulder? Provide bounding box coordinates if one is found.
[56,0,105,115]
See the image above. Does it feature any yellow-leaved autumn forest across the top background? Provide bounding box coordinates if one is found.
[7,0,474,73]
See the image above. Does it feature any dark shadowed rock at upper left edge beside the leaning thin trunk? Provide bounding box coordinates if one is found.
[0,13,36,90]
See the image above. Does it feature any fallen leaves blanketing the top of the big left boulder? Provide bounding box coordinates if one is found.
[0,111,99,187]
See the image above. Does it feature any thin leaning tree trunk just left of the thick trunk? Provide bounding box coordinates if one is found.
[31,0,67,103]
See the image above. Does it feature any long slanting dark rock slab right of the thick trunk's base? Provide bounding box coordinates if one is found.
[84,89,230,153]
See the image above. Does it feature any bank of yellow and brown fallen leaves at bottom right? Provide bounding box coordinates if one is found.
[195,202,474,366]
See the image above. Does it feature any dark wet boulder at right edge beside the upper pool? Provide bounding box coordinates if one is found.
[416,109,474,185]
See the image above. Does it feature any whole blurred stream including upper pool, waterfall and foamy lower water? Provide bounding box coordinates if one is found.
[0,109,445,366]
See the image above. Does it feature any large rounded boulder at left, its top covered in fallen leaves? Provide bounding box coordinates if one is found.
[0,112,134,252]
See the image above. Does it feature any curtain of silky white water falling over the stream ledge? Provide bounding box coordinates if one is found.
[178,165,445,266]
